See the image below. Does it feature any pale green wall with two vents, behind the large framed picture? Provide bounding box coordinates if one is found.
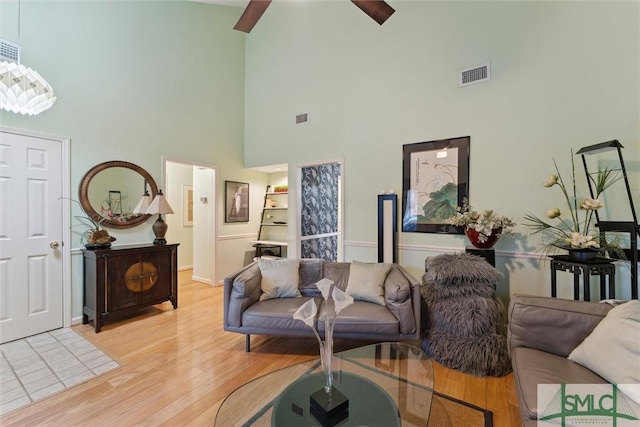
[245,1,640,299]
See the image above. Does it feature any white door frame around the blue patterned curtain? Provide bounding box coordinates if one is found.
[296,157,344,261]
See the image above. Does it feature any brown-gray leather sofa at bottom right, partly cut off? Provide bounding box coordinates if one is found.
[507,295,613,427]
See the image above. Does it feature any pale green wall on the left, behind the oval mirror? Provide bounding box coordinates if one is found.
[0,0,267,319]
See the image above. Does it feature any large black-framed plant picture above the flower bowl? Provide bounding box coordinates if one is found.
[402,136,471,234]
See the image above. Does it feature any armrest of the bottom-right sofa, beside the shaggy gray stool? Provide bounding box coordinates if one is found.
[507,295,613,357]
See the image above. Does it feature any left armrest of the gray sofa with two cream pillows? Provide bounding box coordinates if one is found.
[224,262,262,330]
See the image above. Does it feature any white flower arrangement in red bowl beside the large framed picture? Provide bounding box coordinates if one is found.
[446,198,516,249]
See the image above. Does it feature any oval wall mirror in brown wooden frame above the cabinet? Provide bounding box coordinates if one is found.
[78,160,158,228]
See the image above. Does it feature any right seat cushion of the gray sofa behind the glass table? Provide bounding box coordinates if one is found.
[318,301,400,336]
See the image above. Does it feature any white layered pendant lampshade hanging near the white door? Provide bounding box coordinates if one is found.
[0,61,57,116]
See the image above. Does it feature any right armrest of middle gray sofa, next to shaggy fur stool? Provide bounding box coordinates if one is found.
[384,264,420,336]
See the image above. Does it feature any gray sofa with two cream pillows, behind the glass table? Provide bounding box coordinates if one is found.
[223,259,420,351]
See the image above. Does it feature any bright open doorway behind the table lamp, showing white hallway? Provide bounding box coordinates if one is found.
[163,158,218,285]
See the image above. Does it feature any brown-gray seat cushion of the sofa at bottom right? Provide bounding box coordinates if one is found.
[511,347,607,419]
